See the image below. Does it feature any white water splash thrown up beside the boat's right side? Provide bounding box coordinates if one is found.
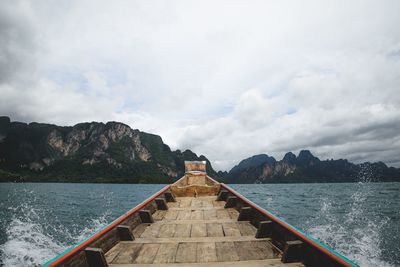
[307,183,393,267]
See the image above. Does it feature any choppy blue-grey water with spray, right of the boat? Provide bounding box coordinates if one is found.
[232,184,400,267]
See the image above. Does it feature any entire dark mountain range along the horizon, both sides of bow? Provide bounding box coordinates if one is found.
[0,117,400,183]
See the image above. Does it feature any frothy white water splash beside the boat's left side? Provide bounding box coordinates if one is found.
[0,198,108,267]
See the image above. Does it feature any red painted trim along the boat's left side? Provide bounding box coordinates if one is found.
[48,185,170,267]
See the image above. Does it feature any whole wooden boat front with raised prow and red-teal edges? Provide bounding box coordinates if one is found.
[44,161,357,267]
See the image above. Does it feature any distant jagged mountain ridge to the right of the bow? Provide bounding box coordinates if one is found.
[219,150,400,183]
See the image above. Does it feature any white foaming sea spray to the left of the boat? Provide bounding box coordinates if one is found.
[0,190,110,267]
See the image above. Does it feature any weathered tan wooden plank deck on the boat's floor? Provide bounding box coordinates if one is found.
[106,197,294,266]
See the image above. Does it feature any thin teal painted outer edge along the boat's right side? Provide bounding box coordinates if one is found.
[221,183,360,267]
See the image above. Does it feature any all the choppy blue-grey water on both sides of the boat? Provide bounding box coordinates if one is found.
[0,183,400,266]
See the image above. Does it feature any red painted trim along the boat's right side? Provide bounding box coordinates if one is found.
[221,183,354,267]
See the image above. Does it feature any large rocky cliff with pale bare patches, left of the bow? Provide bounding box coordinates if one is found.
[0,117,215,182]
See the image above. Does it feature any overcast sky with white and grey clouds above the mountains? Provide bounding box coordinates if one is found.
[0,0,400,170]
